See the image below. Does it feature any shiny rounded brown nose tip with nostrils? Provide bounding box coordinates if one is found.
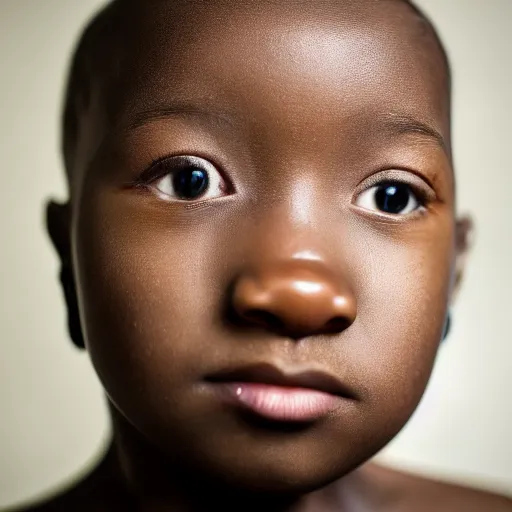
[232,260,356,339]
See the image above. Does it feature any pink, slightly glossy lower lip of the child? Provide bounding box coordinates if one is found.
[214,382,341,422]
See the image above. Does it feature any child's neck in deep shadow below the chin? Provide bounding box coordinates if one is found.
[110,405,374,512]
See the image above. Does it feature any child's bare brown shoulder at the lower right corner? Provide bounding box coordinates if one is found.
[368,464,512,512]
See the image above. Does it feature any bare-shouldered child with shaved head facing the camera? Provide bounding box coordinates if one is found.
[17,0,512,512]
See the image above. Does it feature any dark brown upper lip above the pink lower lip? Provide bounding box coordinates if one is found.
[206,363,357,400]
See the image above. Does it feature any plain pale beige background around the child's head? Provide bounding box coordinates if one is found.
[0,0,512,509]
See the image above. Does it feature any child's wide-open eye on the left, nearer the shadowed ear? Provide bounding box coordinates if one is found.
[147,156,228,201]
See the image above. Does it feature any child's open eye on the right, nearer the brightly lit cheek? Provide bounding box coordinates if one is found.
[356,181,424,215]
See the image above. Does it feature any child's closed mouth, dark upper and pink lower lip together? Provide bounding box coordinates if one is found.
[206,364,357,422]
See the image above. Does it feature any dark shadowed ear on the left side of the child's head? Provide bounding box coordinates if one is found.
[46,201,85,349]
